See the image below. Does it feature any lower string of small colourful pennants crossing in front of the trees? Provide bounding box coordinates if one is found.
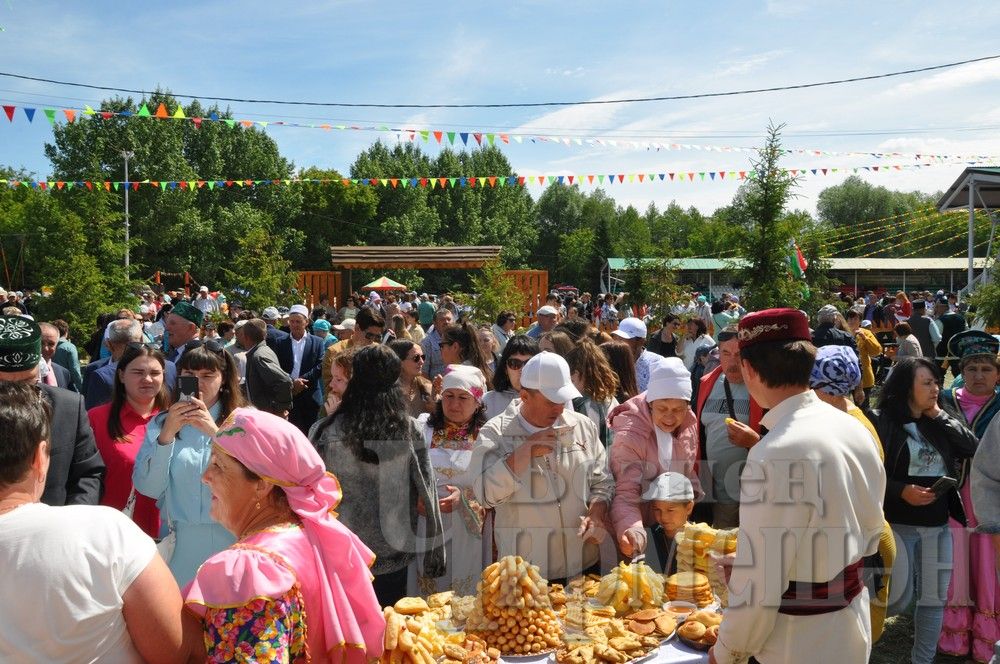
[0,162,986,191]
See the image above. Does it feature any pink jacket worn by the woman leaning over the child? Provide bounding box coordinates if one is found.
[608,392,703,538]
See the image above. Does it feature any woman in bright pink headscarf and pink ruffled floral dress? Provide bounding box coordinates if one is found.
[184,408,385,662]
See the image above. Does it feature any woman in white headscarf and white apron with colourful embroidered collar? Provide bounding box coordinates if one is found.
[416,366,493,595]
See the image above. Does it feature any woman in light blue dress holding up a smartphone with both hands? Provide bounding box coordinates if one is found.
[132,340,244,587]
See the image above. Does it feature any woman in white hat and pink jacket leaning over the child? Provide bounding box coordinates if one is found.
[608,357,702,556]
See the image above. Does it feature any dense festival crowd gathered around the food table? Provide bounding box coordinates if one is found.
[0,287,1000,664]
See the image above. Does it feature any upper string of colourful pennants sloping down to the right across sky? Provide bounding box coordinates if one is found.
[0,103,997,161]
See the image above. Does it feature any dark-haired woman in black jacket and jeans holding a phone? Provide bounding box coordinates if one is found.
[875,357,977,664]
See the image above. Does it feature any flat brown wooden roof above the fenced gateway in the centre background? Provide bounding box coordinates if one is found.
[330,246,503,269]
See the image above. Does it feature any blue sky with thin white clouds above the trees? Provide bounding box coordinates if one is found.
[0,0,1000,212]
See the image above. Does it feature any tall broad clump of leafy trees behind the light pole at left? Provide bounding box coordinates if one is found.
[45,92,302,290]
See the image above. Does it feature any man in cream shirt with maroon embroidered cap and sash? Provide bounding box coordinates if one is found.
[709,309,886,664]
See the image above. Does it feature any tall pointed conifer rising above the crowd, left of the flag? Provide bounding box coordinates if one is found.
[733,124,804,310]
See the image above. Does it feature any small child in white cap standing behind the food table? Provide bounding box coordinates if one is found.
[642,472,694,574]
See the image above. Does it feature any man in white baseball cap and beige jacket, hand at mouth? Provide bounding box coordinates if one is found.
[469,352,614,583]
